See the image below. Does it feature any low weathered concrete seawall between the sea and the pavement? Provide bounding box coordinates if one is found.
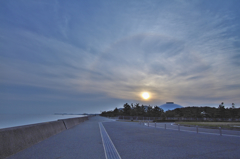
[0,117,88,159]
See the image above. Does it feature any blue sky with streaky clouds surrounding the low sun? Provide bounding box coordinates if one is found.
[0,0,240,114]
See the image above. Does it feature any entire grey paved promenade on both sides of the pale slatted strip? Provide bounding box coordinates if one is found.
[7,116,240,159]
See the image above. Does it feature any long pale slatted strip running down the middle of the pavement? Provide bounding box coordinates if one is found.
[99,122,121,159]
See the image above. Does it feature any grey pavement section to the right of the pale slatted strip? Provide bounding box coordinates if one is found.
[103,122,240,159]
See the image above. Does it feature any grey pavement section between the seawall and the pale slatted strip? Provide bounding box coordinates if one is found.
[9,116,112,159]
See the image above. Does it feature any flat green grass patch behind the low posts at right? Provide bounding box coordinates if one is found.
[175,122,240,130]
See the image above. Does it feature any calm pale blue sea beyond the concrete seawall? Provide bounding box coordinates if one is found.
[0,114,85,129]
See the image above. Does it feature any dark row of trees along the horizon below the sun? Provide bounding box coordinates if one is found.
[101,102,240,119]
